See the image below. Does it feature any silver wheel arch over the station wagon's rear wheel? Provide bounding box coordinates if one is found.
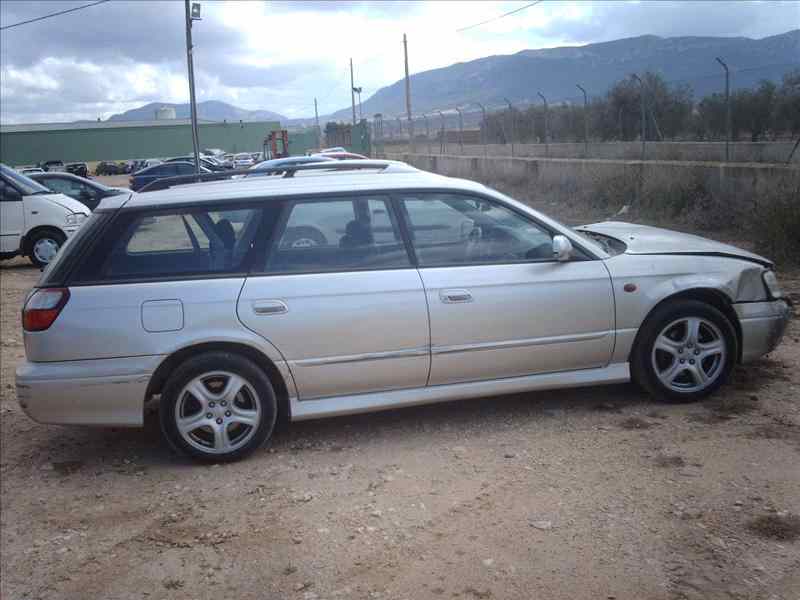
[145,342,291,422]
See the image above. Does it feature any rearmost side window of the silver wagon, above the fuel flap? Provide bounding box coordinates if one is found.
[74,208,262,283]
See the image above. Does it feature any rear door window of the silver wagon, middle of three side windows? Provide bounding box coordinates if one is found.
[266,197,411,273]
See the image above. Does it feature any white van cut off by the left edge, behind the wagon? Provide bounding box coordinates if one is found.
[0,164,89,267]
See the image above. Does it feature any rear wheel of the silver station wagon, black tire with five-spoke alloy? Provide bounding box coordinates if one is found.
[159,352,278,462]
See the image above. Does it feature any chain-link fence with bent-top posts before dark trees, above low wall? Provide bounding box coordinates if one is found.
[371,62,800,163]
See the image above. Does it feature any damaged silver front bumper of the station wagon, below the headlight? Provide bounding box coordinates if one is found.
[733,300,792,362]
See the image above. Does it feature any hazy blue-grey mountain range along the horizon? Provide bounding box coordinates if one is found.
[109,29,800,126]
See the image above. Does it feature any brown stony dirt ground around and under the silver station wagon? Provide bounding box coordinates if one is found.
[0,243,800,600]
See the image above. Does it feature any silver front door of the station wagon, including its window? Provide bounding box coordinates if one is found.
[401,193,614,385]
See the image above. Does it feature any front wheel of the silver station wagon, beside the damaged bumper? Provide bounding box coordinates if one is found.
[631,300,738,403]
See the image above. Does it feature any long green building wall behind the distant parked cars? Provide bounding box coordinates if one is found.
[0,121,282,166]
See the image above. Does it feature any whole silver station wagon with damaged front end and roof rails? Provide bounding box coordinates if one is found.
[17,161,790,461]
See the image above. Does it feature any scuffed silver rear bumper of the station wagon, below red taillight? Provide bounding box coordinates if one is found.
[16,356,163,427]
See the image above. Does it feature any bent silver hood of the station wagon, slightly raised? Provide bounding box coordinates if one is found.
[576,221,772,266]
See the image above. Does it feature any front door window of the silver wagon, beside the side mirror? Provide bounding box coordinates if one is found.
[402,193,553,267]
